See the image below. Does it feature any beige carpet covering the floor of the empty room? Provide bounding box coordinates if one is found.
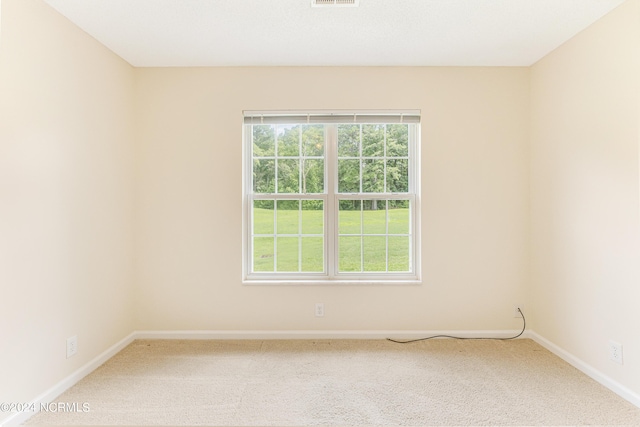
[27,339,640,426]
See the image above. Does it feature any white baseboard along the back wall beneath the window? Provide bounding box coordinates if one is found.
[134,330,526,340]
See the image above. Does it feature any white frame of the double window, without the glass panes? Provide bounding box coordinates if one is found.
[242,110,421,285]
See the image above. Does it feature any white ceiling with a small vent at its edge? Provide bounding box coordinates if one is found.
[44,0,624,67]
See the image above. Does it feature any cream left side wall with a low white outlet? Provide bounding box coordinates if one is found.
[0,0,135,421]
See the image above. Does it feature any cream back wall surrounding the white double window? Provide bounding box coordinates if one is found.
[136,67,529,330]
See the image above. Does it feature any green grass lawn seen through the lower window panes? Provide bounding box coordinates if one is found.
[253,207,409,272]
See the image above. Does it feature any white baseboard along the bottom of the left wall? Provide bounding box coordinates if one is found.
[0,332,136,427]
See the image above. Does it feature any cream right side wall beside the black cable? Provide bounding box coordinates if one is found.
[531,0,640,394]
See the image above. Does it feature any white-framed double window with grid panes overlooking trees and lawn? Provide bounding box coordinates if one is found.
[244,111,420,282]
